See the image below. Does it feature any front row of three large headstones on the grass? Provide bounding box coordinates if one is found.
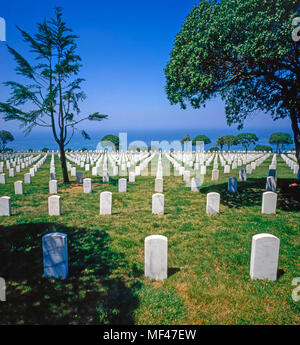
[42,232,280,281]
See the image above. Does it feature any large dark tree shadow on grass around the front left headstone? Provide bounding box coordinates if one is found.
[0,223,141,324]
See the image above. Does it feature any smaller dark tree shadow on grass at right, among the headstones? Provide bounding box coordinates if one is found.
[200,178,300,211]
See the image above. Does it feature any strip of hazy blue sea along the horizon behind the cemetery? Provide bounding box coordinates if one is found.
[7,128,294,152]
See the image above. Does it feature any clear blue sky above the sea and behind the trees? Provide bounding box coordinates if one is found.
[0,0,290,136]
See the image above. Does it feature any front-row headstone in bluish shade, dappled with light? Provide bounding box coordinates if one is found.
[42,232,68,278]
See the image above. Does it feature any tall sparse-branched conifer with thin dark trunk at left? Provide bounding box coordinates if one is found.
[0,7,107,183]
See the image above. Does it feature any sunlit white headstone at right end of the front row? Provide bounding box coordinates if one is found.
[250,234,280,280]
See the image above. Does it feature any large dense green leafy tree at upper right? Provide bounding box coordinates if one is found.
[165,0,300,164]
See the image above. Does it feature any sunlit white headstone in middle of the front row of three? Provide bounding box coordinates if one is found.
[145,235,168,280]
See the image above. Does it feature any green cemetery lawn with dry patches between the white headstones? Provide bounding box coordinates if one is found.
[0,157,300,324]
